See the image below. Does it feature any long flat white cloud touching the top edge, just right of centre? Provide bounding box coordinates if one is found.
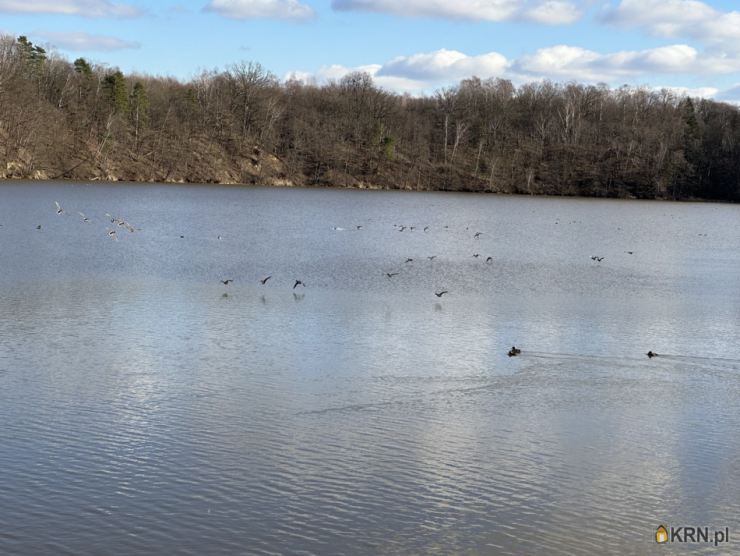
[331,0,583,25]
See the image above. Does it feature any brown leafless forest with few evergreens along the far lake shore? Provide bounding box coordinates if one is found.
[0,35,740,201]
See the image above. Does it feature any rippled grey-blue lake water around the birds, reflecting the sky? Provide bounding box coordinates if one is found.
[0,182,740,555]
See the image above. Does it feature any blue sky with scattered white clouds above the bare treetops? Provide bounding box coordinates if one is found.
[0,0,740,102]
